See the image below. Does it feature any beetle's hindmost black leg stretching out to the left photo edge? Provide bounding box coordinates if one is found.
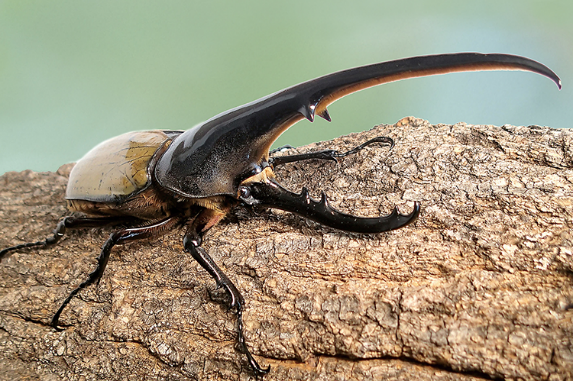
[0,216,131,260]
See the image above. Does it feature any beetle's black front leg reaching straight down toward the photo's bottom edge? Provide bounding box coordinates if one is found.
[183,214,271,376]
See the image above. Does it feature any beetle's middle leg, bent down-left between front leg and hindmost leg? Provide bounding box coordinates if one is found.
[50,217,181,329]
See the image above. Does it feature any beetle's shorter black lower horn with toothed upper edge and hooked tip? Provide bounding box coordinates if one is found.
[239,179,420,233]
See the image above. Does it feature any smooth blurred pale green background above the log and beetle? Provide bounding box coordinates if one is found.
[0,0,573,174]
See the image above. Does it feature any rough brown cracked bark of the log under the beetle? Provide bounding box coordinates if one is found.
[0,118,573,380]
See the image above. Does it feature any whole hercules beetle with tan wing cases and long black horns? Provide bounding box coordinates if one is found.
[0,53,561,375]
